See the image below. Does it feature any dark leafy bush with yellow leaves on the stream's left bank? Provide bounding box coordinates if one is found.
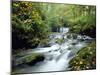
[12,1,48,49]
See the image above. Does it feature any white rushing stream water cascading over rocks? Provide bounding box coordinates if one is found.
[13,28,92,73]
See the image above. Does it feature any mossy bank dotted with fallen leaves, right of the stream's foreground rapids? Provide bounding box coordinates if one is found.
[69,42,96,70]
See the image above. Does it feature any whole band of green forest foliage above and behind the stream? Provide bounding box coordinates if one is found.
[12,1,96,49]
